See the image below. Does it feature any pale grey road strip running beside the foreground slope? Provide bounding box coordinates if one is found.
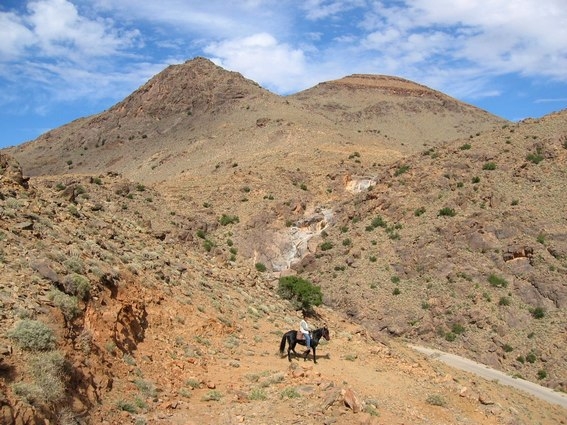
[408,345,567,408]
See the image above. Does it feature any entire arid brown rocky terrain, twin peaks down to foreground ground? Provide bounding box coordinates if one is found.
[0,58,567,424]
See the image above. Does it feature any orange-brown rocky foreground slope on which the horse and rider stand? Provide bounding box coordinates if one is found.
[0,151,565,424]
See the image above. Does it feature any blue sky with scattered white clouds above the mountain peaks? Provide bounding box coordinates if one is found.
[0,0,567,147]
